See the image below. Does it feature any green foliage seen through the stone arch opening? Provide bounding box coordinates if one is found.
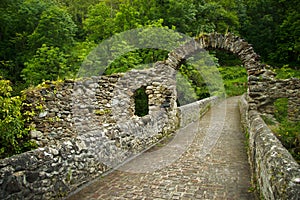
[176,52,225,105]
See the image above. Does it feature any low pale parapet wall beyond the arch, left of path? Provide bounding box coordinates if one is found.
[178,96,219,127]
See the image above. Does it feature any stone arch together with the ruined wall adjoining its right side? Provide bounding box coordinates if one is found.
[166,33,300,121]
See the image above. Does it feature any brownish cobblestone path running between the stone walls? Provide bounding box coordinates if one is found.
[68,97,255,200]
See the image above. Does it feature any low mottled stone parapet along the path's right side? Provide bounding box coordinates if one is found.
[240,96,300,200]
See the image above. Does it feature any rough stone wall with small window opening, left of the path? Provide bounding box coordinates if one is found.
[0,63,178,199]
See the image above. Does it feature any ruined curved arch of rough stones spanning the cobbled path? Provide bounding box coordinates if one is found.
[165,33,274,109]
